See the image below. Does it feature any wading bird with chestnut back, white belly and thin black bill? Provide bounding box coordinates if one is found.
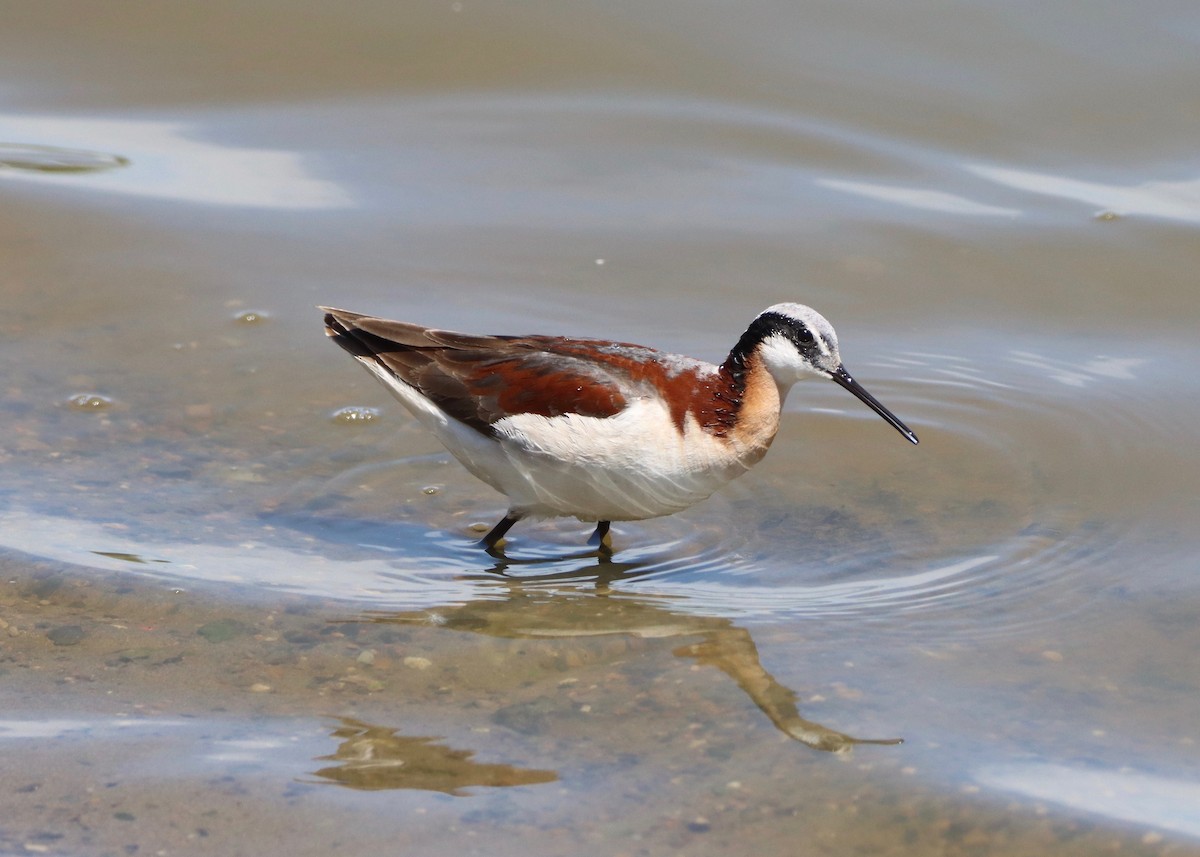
[320,304,917,551]
